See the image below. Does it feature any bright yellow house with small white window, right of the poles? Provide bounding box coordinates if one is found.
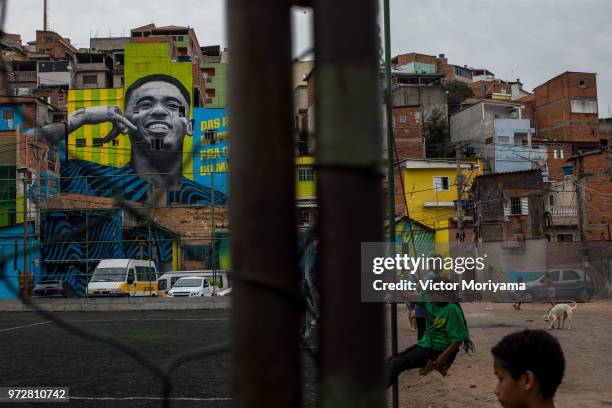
[402,159,482,254]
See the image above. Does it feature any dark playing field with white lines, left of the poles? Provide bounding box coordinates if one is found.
[0,309,316,408]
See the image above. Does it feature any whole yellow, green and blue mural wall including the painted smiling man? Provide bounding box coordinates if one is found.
[62,42,228,205]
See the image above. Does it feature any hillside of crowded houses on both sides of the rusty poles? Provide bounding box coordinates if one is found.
[0,30,612,296]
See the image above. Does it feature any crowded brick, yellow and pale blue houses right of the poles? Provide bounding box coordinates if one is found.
[384,53,612,298]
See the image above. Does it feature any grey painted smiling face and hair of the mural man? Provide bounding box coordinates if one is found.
[125,81,192,152]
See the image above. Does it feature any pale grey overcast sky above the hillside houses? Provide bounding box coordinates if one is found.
[6,0,612,117]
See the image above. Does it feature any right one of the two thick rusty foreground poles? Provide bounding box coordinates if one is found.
[314,0,385,408]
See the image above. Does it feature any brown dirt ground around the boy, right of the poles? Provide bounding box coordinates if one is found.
[388,301,612,408]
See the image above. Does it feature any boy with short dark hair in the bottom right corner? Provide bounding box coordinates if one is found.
[491,330,565,408]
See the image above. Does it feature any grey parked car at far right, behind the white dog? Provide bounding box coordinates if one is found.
[525,268,595,302]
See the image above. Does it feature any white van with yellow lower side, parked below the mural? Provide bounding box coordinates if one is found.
[87,259,159,297]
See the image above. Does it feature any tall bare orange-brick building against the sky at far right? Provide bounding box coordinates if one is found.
[534,72,600,180]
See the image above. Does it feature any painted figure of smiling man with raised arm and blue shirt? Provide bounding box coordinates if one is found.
[30,74,227,204]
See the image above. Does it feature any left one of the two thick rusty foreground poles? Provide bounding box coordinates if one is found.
[227,0,301,407]
